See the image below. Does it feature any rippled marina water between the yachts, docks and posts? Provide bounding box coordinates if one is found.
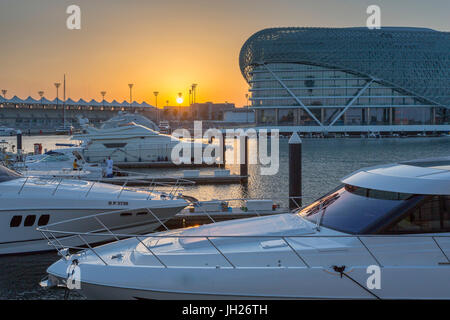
[0,136,450,299]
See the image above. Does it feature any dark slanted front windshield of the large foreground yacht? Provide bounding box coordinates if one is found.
[298,185,414,234]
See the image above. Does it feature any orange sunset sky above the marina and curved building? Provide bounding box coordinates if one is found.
[0,0,450,107]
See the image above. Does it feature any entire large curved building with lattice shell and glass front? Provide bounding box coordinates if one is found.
[239,27,450,131]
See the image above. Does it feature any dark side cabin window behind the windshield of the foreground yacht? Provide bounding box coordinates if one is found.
[382,196,450,234]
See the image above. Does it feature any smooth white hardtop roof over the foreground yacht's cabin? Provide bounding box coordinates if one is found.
[341,157,450,195]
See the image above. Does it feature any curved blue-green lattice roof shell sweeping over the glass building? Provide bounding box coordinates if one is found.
[239,27,450,107]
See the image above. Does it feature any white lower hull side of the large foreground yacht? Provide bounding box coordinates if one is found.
[51,266,450,300]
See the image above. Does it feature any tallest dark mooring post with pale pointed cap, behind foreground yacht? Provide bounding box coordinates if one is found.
[289,132,302,210]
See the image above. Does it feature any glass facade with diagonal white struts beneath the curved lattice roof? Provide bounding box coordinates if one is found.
[249,63,449,126]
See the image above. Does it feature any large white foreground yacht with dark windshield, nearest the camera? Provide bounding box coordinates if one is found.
[43,157,450,299]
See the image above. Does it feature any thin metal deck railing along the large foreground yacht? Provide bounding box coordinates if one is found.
[37,202,450,269]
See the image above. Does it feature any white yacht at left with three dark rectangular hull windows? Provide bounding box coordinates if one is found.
[0,166,188,255]
